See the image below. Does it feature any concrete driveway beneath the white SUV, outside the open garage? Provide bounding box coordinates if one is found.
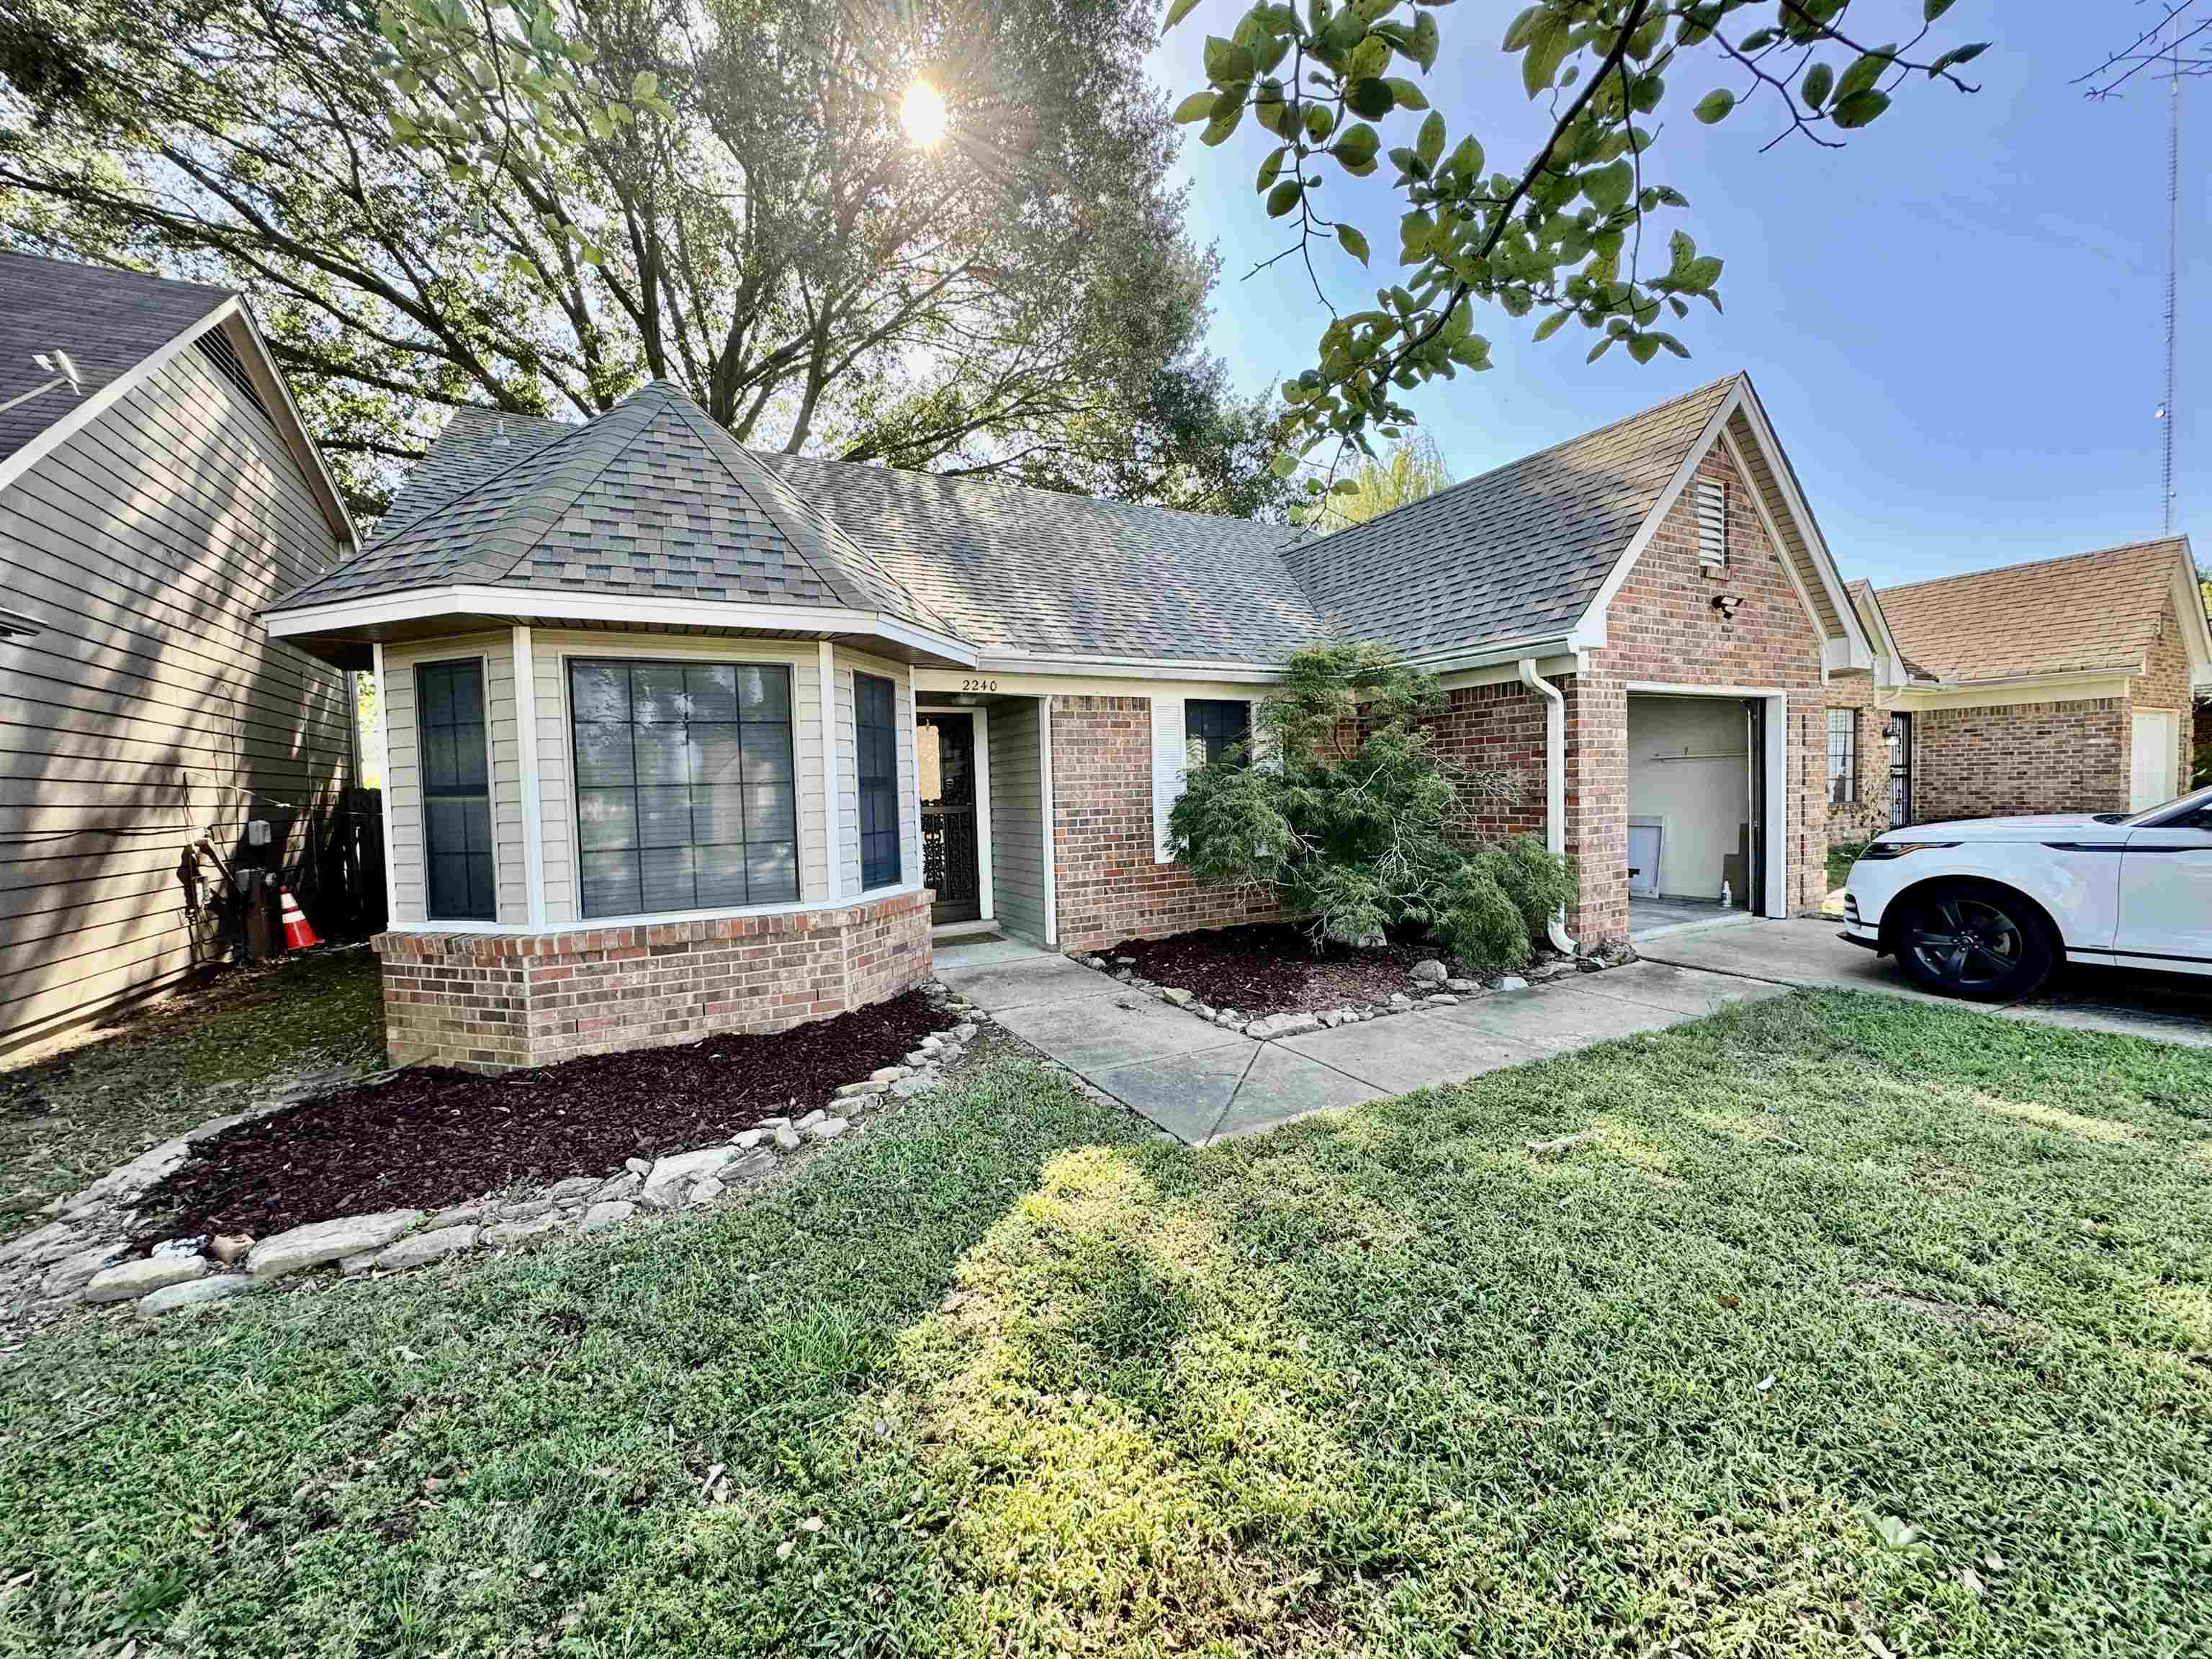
[1637,918,2212,1048]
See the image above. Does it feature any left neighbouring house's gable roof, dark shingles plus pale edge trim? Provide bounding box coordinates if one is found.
[0,252,359,547]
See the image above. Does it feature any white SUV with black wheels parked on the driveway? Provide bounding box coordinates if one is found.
[1843,790,2212,1002]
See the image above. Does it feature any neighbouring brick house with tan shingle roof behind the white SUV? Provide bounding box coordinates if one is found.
[1827,535,2212,840]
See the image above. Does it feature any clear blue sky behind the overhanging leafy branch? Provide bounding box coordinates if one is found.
[1153,0,2212,584]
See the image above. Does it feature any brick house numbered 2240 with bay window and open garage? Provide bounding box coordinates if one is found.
[266,376,1874,1069]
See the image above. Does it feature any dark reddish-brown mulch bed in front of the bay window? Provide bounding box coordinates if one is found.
[140,991,951,1243]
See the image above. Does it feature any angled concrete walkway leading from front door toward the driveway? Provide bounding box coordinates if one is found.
[938,945,1783,1146]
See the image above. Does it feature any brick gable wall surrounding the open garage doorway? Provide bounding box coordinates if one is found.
[1562,444,1827,945]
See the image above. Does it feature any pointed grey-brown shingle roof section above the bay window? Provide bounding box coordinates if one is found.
[283,382,945,633]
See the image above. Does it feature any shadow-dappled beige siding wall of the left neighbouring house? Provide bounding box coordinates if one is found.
[0,338,351,1048]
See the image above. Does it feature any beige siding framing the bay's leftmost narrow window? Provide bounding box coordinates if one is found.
[380,633,531,925]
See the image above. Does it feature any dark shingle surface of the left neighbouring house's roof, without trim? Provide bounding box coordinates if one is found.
[0,252,233,473]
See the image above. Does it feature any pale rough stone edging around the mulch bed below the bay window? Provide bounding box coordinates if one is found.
[0,980,991,1325]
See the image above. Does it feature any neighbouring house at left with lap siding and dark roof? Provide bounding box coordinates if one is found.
[0,254,354,1048]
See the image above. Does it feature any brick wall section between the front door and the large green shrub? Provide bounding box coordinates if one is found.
[1053,697,1277,949]
